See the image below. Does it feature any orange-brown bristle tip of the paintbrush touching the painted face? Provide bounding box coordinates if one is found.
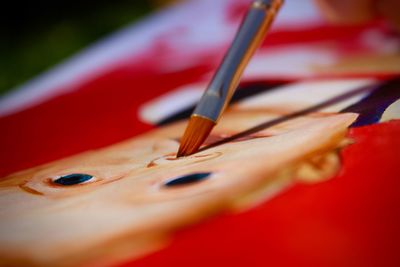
[177,116,215,157]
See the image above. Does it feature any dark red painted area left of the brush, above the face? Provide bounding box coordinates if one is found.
[0,62,209,177]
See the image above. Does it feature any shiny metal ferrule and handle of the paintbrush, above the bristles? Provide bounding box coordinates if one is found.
[193,0,283,122]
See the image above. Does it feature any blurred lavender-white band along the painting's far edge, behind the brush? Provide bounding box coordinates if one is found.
[0,0,319,116]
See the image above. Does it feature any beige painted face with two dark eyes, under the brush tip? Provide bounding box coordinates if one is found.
[0,110,357,266]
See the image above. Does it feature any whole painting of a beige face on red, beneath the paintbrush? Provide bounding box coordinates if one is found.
[0,1,400,266]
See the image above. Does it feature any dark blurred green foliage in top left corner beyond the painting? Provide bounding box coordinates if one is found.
[0,0,160,95]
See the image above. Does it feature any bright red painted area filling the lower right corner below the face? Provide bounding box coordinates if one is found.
[123,121,400,267]
